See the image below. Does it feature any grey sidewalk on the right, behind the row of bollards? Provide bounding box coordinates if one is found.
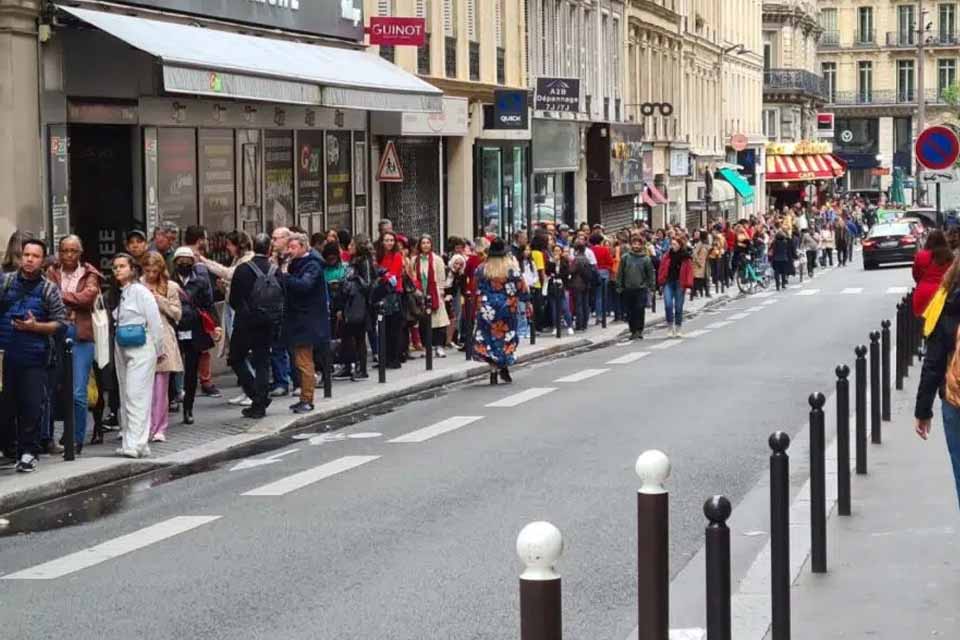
[767,390,960,640]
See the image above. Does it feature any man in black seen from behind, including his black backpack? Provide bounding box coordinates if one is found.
[229,233,284,419]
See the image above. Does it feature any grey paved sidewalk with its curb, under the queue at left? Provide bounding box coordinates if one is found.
[0,289,737,514]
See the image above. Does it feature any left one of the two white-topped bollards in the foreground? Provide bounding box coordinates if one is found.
[517,522,563,640]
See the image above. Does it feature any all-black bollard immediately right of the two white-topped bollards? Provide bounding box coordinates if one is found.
[703,496,733,640]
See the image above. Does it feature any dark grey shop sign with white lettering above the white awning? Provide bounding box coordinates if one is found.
[114,0,363,42]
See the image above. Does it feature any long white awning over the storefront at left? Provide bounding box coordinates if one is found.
[59,6,443,113]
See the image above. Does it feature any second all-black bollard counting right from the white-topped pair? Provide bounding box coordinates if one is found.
[768,431,790,640]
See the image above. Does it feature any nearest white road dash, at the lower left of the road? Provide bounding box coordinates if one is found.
[0,516,220,580]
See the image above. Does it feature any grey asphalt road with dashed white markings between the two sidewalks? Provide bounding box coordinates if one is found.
[0,261,910,640]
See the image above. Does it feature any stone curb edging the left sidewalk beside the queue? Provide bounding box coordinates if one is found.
[0,292,735,515]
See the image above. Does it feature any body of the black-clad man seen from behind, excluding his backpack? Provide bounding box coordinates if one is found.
[229,233,278,418]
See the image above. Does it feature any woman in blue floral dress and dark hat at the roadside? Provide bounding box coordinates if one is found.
[473,238,533,382]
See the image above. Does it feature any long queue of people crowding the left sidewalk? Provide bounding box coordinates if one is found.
[0,192,872,472]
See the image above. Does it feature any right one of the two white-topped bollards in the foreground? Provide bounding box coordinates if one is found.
[636,449,670,640]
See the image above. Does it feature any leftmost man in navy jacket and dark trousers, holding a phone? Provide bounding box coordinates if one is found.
[0,240,67,473]
